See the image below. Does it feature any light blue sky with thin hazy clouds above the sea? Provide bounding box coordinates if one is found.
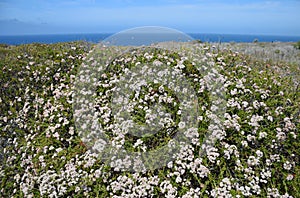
[0,0,300,36]
